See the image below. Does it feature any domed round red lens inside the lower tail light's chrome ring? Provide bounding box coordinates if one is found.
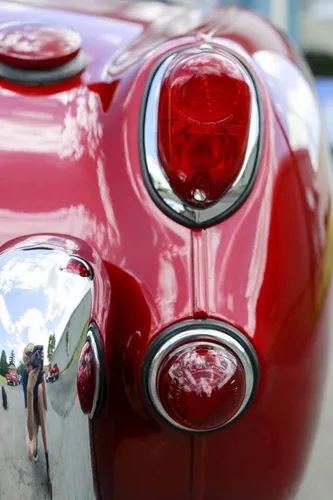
[157,342,246,431]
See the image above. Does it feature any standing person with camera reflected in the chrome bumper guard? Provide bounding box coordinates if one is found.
[22,344,48,462]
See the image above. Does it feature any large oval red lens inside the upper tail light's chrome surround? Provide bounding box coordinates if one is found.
[158,50,251,208]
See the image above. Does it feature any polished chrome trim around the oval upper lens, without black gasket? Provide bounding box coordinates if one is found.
[143,44,260,225]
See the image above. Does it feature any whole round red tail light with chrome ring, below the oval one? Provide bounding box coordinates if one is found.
[143,326,258,432]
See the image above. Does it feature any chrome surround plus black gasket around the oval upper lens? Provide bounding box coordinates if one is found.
[140,44,263,228]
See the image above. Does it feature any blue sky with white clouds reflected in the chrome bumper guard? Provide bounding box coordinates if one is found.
[0,250,89,364]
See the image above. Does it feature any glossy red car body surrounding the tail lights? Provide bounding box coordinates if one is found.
[0,1,333,500]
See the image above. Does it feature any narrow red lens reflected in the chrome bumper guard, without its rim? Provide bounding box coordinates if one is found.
[77,341,96,414]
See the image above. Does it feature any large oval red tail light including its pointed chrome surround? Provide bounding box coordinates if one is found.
[143,45,259,227]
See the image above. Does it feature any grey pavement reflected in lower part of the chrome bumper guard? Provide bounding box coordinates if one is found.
[0,381,94,500]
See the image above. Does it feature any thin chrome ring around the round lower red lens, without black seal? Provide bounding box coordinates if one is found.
[148,328,254,433]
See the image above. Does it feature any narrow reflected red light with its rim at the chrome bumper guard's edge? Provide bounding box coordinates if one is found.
[77,325,104,419]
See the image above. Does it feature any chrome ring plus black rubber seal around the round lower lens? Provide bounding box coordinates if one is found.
[142,320,259,433]
